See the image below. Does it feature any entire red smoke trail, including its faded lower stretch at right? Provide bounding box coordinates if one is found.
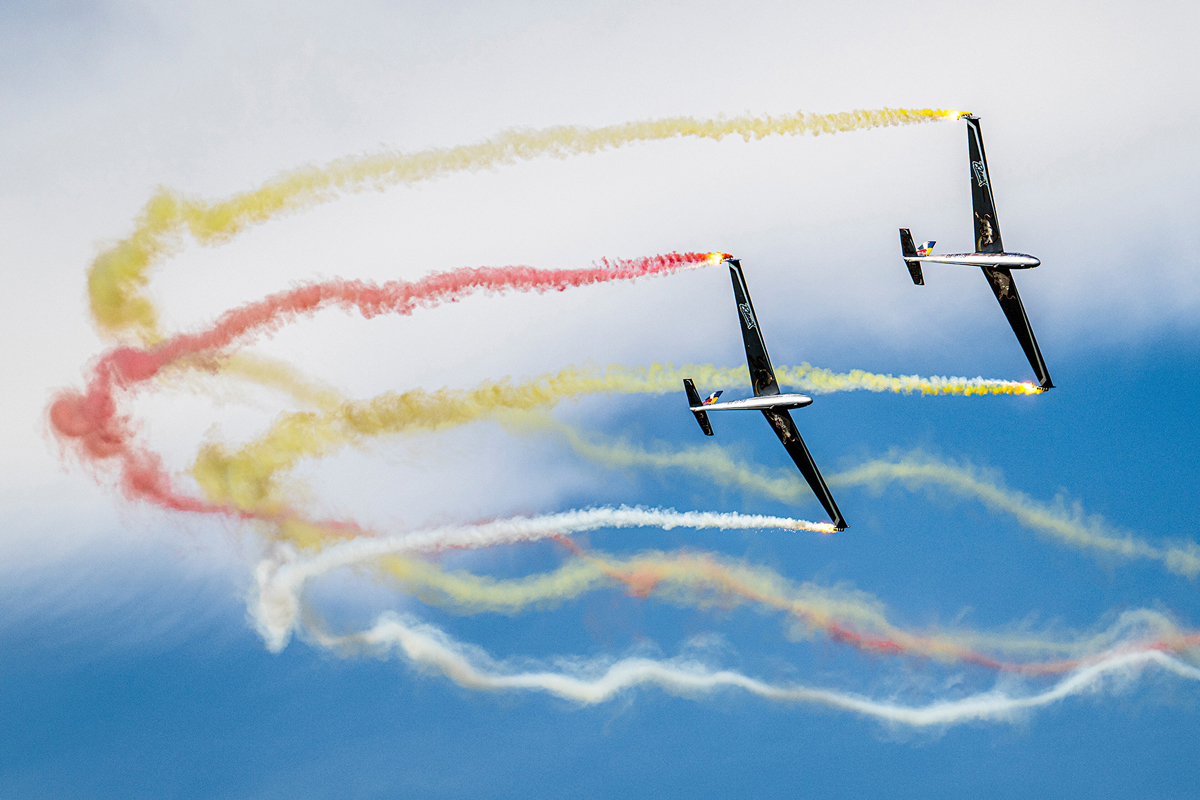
[48,253,1200,675]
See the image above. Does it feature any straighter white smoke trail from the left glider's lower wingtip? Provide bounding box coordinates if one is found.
[250,506,833,652]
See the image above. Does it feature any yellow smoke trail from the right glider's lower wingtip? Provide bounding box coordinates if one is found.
[192,356,1028,522]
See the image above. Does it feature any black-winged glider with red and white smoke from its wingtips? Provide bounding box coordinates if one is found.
[683,255,846,530]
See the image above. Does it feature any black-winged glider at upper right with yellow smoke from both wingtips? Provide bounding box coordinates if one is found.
[900,114,1054,391]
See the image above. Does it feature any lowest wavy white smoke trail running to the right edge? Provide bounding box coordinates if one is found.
[313,613,1200,727]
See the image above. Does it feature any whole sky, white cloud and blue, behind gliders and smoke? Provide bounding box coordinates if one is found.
[0,4,1200,798]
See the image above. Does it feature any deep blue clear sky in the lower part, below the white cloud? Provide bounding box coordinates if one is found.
[7,343,1200,798]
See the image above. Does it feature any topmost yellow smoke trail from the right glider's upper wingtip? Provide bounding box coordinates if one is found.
[88,108,960,342]
